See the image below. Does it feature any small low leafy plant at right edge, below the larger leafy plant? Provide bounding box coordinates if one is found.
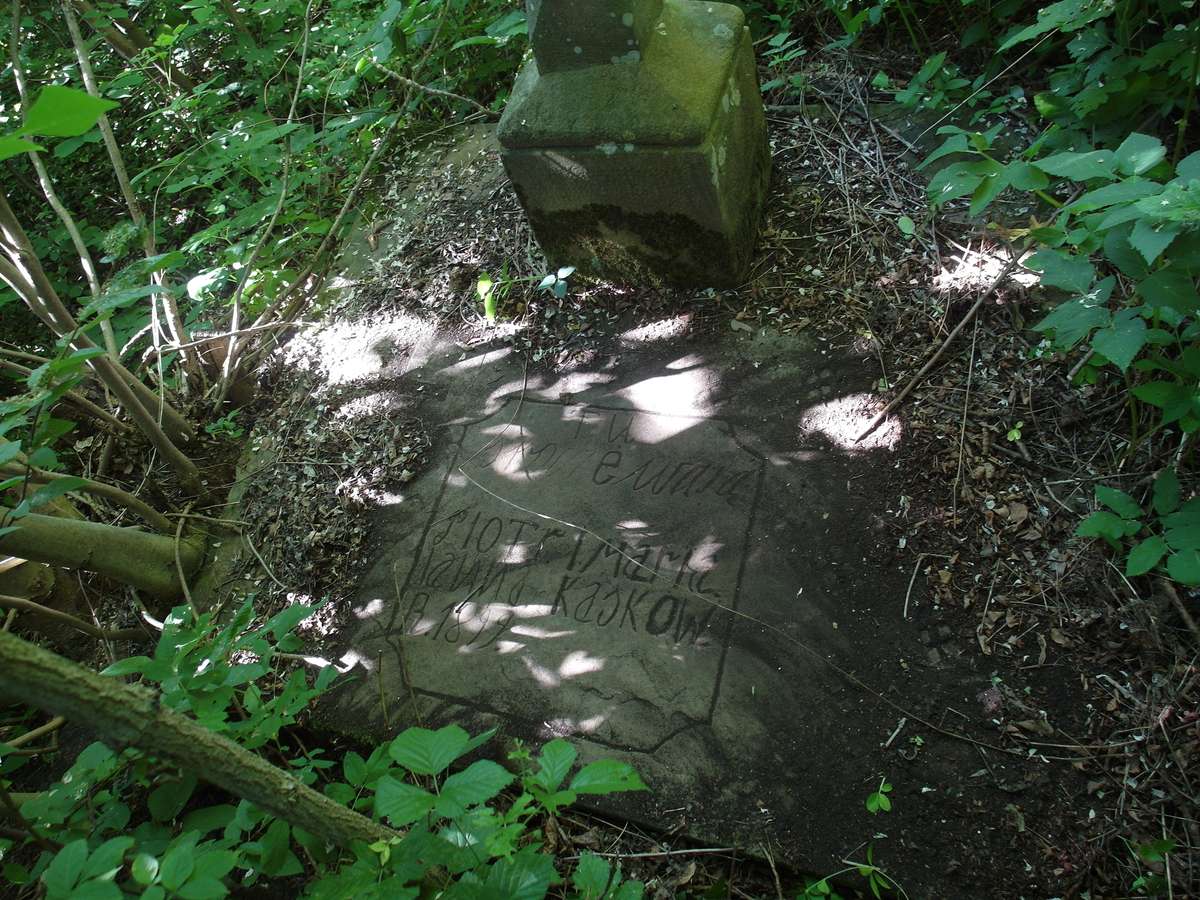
[1075,468,1200,584]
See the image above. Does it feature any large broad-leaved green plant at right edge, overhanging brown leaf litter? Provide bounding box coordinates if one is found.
[922,126,1200,440]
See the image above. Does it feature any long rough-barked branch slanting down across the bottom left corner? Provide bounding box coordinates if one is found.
[0,632,400,847]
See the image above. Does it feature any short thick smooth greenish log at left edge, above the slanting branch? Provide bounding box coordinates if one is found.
[0,506,204,600]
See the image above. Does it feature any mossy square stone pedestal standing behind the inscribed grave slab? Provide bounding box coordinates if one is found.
[499,0,770,287]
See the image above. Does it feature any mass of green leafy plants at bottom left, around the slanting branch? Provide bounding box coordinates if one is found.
[0,601,646,900]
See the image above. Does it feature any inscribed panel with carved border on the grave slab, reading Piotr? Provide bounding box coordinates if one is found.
[365,398,764,754]
